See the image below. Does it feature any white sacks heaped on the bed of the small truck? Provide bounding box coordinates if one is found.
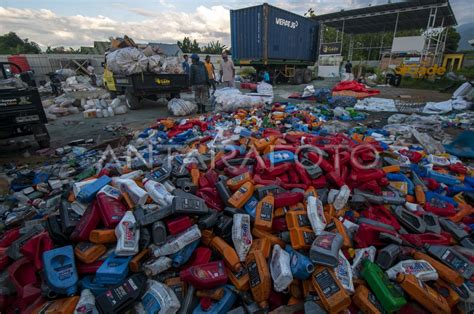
[106,46,183,75]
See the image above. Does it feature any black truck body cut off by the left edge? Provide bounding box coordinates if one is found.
[0,62,50,148]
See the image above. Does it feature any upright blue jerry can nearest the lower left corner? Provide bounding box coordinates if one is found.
[43,245,78,295]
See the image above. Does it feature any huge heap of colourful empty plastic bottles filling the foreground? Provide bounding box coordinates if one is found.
[0,104,474,313]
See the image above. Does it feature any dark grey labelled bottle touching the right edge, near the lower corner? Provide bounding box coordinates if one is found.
[425,244,474,279]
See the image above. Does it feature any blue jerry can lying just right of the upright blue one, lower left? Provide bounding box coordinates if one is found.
[96,254,132,285]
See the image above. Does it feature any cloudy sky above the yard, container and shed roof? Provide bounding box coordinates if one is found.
[0,0,474,49]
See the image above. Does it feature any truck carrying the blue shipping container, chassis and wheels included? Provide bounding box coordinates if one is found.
[230,3,319,84]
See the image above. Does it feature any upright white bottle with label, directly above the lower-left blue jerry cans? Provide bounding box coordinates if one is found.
[115,211,140,256]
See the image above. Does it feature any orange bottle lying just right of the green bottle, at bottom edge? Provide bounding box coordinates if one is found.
[396,273,451,313]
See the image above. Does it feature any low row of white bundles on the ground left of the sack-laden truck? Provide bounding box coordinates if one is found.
[81,96,128,118]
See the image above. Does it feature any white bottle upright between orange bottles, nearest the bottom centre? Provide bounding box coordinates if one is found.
[270,244,293,292]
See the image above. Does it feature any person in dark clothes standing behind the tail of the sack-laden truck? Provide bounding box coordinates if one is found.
[190,53,209,113]
